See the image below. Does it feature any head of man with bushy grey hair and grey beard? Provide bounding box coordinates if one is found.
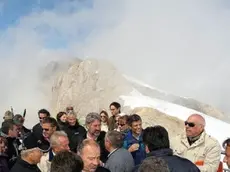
[85,112,101,137]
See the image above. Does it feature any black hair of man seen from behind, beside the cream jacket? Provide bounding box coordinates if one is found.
[143,125,169,152]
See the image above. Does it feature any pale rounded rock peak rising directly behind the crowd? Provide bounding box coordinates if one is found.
[52,60,132,121]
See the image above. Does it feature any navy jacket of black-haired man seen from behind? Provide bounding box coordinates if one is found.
[135,149,200,172]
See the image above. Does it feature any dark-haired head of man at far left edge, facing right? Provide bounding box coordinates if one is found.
[1,120,19,138]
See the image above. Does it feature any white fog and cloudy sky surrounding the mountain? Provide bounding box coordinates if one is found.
[0,0,230,125]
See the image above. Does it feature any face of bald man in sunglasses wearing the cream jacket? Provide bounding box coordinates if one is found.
[185,116,204,137]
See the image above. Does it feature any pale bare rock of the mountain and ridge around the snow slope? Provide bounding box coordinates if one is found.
[51,59,229,127]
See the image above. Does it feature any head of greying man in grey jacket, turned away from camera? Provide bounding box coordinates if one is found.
[105,130,124,152]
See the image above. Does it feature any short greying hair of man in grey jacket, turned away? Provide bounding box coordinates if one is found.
[106,130,124,148]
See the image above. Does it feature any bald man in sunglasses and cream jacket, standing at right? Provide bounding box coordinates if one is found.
[171,114,221,172]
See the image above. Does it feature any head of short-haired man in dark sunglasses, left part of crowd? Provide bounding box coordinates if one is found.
[42,117,58,138]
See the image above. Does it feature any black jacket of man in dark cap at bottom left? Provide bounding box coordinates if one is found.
[10,158,41,172]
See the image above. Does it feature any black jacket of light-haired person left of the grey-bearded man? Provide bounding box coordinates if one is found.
[63,123,86,152]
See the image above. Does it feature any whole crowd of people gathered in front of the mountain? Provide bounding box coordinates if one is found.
[0,102,230,172]
